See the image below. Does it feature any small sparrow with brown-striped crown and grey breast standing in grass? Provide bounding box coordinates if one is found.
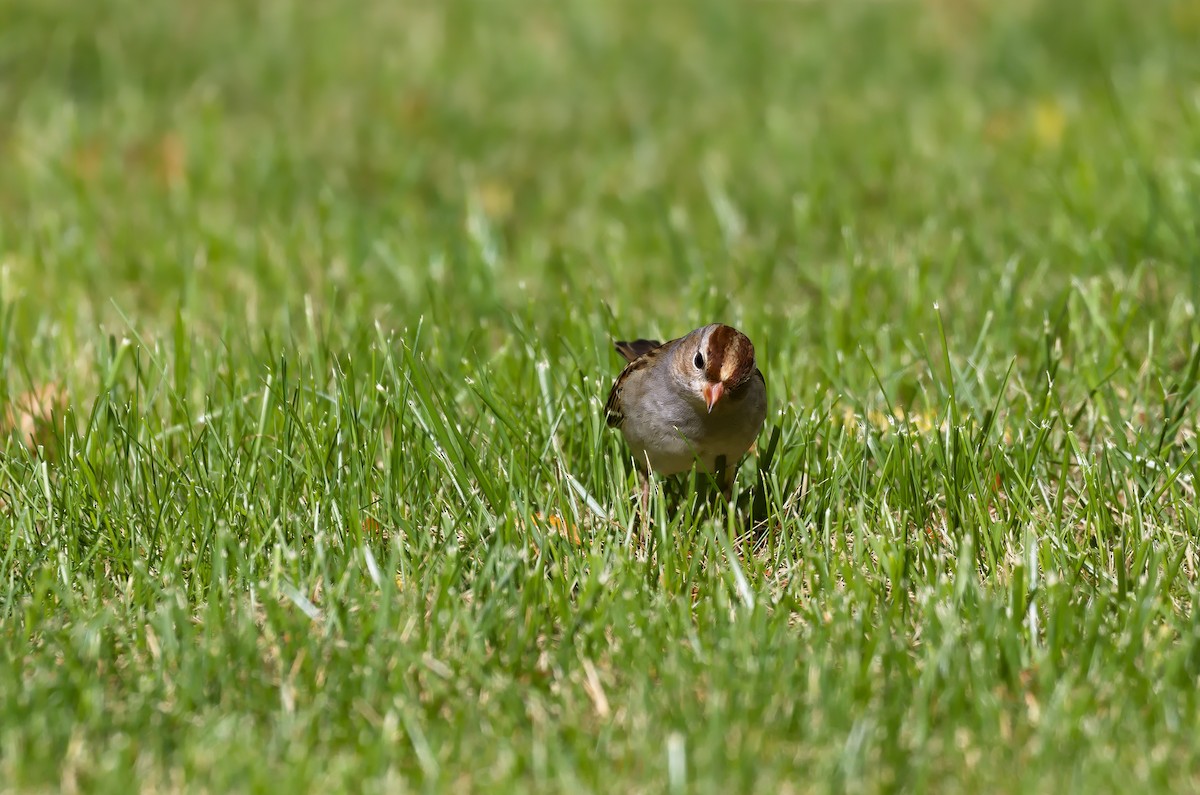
[605,323,767,506]
